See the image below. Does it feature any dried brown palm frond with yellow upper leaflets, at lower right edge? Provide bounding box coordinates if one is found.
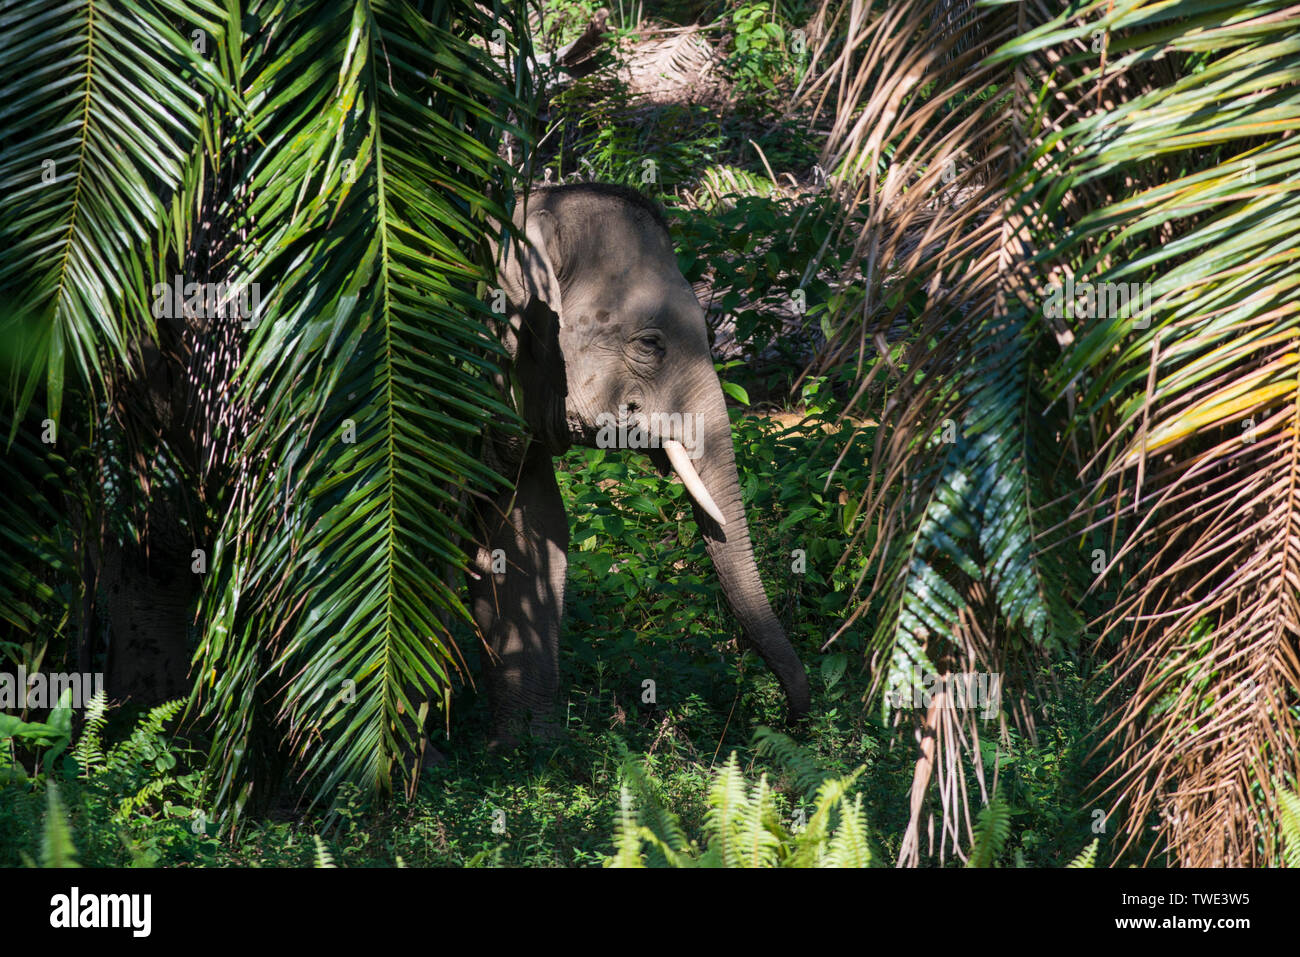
[1086,243,1300,866]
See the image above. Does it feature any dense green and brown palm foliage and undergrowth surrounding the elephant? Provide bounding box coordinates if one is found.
[0,0,1300,866]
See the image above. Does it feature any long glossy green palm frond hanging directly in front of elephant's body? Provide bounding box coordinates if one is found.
[187,3,527,807]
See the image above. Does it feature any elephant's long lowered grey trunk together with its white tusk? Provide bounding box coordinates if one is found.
[666,379,810,718]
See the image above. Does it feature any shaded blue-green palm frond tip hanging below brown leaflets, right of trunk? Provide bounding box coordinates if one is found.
[874,308,1087,712]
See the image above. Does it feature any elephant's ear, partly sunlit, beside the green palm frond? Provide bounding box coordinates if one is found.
[499,209,569,454]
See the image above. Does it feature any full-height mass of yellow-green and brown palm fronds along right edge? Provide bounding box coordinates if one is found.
[1026,4,1300,866]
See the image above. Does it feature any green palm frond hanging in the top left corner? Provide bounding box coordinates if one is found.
[0,0,225,420]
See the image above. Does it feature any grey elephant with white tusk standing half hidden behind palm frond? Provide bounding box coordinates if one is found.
[468,183,809,749]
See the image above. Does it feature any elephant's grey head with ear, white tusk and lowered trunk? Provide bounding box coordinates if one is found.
[475,185,809,738]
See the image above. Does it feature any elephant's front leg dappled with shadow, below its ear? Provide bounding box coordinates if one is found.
[469,446,568,748]
